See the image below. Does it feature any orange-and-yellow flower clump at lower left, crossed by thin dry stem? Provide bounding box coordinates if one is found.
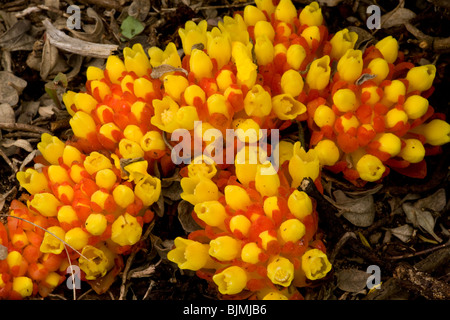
[0,134,161,299]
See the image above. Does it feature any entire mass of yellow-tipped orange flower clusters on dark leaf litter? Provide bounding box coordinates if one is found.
[0,0,450,300]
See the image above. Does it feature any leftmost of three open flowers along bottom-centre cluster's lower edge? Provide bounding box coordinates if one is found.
[213,266,248,294]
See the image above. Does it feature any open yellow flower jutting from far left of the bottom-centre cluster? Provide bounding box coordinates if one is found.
[167,237,214,271]
